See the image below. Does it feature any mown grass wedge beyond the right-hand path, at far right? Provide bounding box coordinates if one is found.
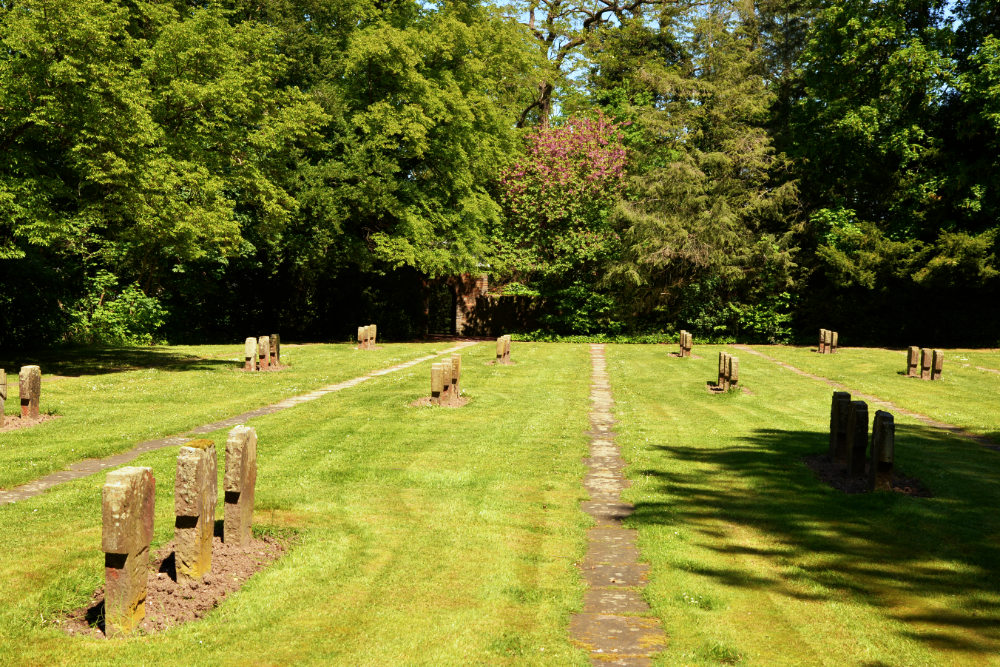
[743,345,1000,444]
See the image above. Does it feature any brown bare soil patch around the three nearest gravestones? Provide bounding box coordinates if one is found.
[62,537,287,639]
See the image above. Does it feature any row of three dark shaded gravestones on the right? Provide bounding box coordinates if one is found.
[829,391,896,491]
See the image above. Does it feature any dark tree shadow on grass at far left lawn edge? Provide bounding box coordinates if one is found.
[0,345,234,381]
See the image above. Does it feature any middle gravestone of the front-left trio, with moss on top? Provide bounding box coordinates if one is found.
[174,440,219,581]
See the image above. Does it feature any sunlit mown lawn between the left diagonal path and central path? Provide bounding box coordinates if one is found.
[0,343,590,665]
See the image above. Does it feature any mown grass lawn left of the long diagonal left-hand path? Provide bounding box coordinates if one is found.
[0,343,451,488]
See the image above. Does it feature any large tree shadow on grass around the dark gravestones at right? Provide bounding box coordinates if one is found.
[630,424,1000,654]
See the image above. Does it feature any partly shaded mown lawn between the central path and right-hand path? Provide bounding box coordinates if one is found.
[608,345,1000,665]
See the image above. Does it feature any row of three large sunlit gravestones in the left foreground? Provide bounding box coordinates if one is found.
[101,426,257,637]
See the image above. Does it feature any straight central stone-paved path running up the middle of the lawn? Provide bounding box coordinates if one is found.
[570,345,667,665]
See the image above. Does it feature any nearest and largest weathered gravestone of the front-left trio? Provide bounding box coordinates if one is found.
[101,466,156,637]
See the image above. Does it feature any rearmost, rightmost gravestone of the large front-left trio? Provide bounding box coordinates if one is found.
[222,426,257,548]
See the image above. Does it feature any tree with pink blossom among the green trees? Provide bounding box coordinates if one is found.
[498,112,626,331]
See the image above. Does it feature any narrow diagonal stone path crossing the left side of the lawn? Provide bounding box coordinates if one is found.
[0,341,476,505]
